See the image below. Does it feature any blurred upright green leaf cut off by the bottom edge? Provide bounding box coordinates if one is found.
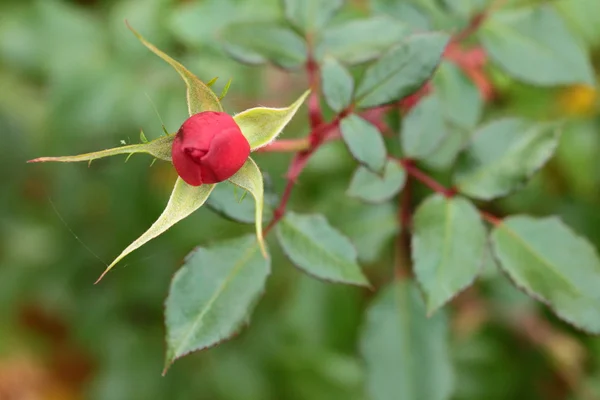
[360,281,454,400]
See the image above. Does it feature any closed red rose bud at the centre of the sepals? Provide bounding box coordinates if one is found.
[171,111,250,186]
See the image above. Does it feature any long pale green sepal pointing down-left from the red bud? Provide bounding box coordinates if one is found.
[96,177,215,283]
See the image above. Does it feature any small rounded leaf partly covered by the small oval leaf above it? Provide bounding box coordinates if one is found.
[346,160,406,203]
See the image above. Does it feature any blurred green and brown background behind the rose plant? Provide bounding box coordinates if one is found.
[0,0,600,400]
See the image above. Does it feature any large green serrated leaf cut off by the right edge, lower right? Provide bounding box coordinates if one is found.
[492,216,600,334]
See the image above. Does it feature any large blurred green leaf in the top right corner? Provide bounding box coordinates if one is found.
[480,5,595,86]
